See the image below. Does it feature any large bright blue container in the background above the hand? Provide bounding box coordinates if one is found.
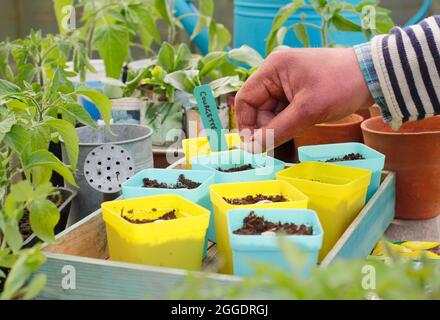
[234,0,366,56]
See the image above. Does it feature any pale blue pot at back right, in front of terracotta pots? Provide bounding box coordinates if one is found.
[298,142,385,201]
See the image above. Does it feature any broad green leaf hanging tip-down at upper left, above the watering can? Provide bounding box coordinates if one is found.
[94,25,130,79]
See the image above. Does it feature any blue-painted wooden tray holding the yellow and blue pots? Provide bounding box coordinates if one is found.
[34,160,396,299]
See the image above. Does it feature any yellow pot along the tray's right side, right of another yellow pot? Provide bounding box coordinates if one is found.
[277,162,372,261]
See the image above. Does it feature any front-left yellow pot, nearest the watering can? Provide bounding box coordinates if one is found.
[101,195,210,271]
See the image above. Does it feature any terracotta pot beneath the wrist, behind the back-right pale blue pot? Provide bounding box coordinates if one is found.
[295,114,364,148]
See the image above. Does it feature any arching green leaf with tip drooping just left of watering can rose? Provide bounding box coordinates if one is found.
[24,150,77,186]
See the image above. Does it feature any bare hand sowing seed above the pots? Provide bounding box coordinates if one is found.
[235,48,374,152]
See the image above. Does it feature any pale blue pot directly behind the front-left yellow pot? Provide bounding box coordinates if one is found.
[122,169,215,249]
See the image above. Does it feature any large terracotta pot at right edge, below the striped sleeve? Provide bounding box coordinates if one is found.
[362,117,440,219]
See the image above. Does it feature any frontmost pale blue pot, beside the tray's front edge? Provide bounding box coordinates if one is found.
[228,209,324,277]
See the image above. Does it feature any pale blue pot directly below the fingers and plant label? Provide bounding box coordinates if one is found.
[191,150,285,184]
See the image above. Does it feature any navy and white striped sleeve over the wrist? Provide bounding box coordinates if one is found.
[371,16,440,129]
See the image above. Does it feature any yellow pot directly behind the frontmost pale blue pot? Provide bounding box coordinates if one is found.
[210,180,308,274]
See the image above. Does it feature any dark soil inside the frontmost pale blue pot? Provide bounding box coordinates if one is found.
[234,211,313,236]
